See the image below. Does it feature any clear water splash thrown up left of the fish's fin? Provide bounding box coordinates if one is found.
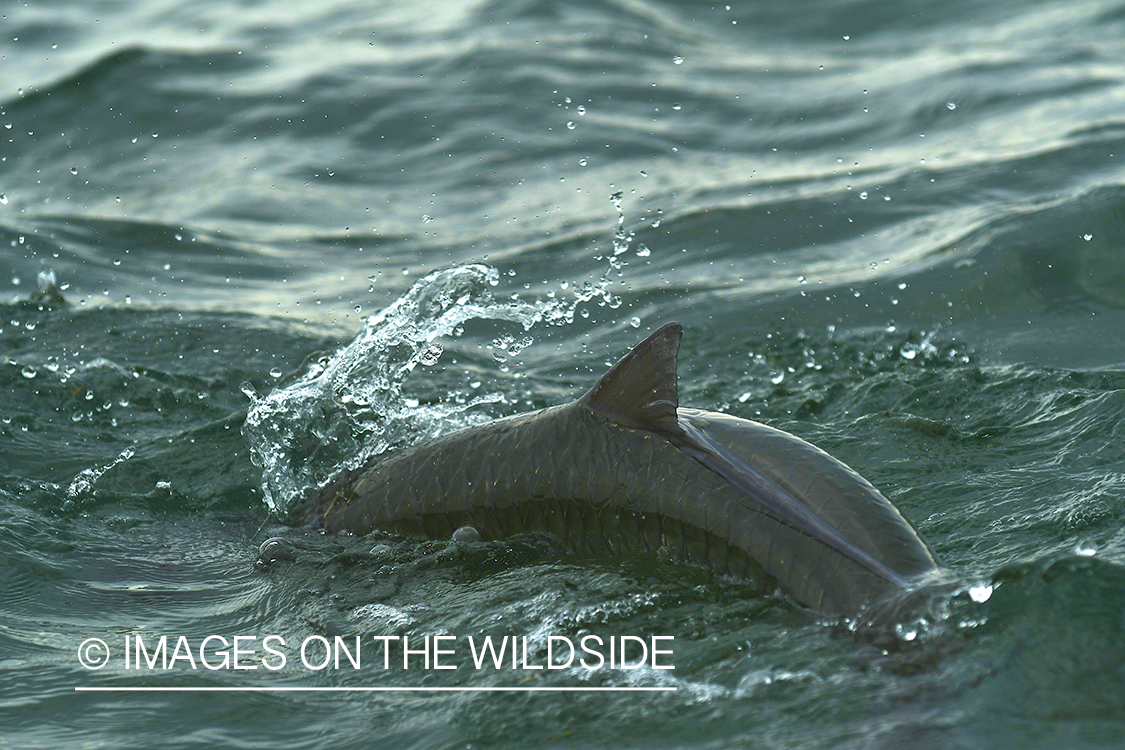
[242,246,623,515]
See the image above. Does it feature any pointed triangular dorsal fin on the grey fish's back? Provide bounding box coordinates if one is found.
[578,323,684,434]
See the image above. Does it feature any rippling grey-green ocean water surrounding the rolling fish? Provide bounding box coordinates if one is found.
[0,0,1125,749]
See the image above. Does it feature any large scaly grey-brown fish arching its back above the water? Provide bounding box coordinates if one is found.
[288,323,938,616]
